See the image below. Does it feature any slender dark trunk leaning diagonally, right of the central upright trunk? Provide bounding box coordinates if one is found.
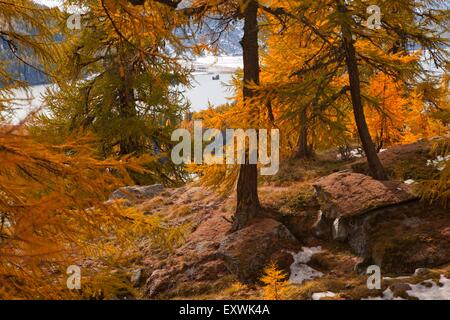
[338,1,388,180]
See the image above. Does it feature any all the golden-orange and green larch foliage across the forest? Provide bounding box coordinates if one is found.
[0,0,450,300]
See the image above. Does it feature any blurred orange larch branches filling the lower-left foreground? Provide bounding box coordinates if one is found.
[0,129,188,299]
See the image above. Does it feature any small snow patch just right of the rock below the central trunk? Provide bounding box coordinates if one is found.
[289,247,323,284]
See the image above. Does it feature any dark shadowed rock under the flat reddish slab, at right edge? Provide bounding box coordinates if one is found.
[356,201,450,274]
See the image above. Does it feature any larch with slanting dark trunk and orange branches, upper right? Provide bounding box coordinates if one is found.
[262,0,448,180]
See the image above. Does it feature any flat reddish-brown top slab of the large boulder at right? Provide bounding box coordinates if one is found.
[314,171,416,220]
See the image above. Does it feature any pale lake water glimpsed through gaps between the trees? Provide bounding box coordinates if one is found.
[8,73,234,123]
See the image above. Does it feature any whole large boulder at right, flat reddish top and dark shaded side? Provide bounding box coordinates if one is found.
[314,171,450,274]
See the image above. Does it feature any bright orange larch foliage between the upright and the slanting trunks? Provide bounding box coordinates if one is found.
[258,1,348,158]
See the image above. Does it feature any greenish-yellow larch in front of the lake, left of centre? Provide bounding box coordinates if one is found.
[38,0,192,184]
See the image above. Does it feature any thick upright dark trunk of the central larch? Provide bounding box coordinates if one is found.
[233,0,260,231]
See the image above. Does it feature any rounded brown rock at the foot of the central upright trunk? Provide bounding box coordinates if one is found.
[218,219,299,283]
